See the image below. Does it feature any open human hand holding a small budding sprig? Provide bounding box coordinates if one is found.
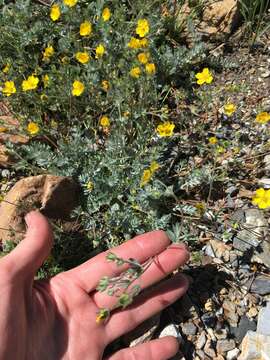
[0,212,188,360]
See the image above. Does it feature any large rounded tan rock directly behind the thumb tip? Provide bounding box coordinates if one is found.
[0,175,79,242]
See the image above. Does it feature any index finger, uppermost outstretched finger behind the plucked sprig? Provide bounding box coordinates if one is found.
[66,230,170,292]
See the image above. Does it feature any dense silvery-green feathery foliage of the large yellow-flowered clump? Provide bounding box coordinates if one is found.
[0,0,205,256]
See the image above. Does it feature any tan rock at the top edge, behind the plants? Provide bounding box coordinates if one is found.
[199,0,239,38]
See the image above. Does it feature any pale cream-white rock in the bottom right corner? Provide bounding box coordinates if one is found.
[239,331,270,360]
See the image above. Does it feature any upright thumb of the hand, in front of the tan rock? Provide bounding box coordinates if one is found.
[3,211,53,277]
